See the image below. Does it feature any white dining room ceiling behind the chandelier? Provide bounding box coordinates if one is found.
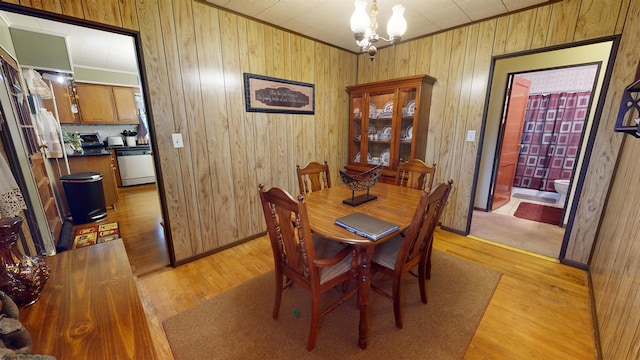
[206,0,555,52]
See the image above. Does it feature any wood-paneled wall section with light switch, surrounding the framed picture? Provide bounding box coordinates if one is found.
[137,0,356,260]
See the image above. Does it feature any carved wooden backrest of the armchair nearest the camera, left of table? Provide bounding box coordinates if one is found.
[259,184,320,283]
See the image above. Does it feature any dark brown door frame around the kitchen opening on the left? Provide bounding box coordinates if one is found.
[0,2,176,266]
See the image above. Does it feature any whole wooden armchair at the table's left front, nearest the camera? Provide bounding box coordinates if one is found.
[259,184,358,350]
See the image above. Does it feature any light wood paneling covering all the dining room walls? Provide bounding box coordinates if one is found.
[7,0,640,359]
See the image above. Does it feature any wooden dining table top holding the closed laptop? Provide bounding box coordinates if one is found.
[304,182,424,244]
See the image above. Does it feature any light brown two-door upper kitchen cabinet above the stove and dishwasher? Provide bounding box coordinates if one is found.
[76,83,138,124]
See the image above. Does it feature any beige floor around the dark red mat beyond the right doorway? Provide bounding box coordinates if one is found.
[469,188,564,259]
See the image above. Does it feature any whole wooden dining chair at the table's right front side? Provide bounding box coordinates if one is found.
[371,180,453,329]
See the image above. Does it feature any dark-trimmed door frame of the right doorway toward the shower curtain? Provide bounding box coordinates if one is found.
[465,36,620,268]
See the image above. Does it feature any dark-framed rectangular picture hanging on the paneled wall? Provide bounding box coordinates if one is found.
[244,73,315,115]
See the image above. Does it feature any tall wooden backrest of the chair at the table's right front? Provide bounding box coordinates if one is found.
[395,180,453,269]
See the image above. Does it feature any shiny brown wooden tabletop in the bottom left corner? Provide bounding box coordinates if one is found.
[20,239,156,360]
